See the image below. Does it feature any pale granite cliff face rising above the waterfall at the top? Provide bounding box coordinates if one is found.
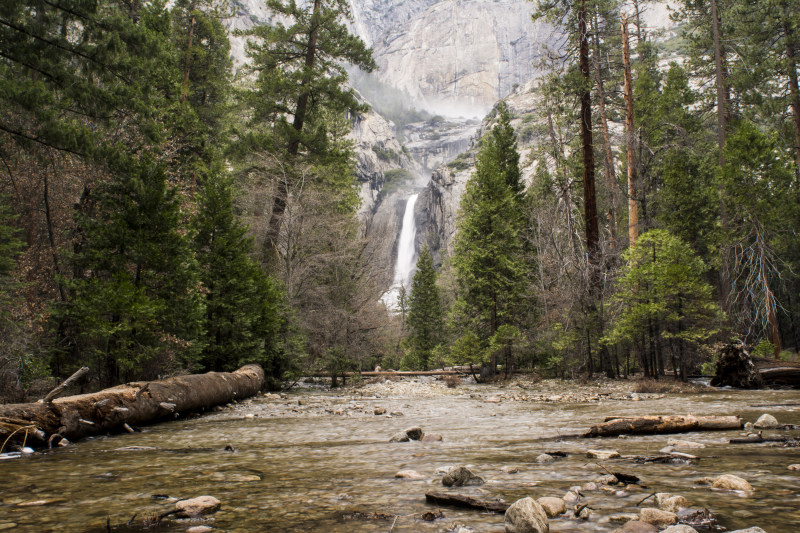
[350,0,550,116]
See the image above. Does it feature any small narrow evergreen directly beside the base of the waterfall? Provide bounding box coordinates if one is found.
[408,246,444,370]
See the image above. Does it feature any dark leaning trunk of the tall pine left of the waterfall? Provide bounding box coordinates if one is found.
[264,0,322,256]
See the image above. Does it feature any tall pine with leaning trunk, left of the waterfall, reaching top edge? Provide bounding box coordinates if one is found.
[239,0,375,254]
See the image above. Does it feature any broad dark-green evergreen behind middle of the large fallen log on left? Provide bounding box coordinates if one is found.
[54,154,203,384]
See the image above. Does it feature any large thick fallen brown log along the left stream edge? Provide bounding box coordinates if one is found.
[0,365,264,444]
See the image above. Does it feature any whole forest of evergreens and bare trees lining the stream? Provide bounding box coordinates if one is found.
[0,0,800,401]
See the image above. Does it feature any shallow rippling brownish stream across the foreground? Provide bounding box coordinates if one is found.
[0,384,800,533]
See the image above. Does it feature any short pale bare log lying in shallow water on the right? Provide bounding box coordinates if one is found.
[584,415,743,437]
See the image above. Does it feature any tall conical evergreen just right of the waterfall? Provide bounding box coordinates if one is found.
[453,101,528,373]
